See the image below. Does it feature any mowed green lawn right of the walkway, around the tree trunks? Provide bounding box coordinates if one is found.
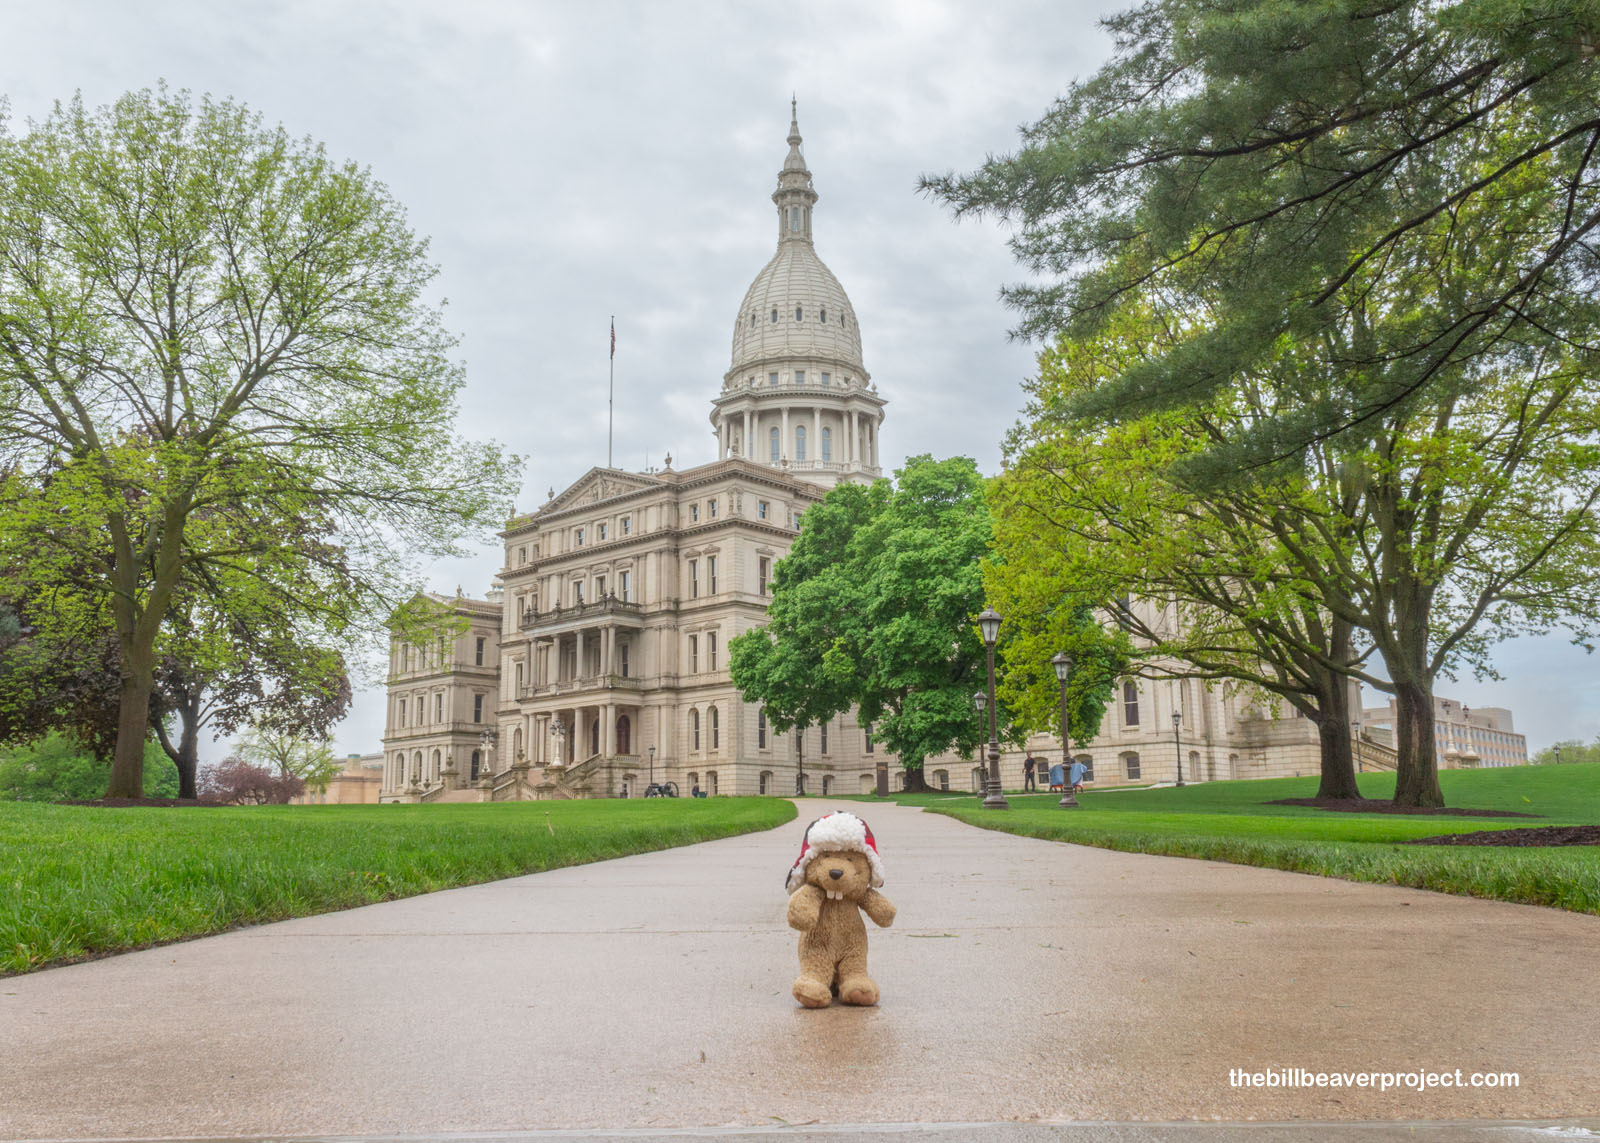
[864,765,1600,914]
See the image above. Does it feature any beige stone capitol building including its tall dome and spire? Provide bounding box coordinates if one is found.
[379,114,1509,802]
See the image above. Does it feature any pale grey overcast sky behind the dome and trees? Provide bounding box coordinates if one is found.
[0,0,1600,756]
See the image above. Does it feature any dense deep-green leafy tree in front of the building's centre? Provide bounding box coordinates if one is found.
[728,456,990,770]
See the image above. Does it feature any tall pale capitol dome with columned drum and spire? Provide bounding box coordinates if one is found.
[710,104,885,488]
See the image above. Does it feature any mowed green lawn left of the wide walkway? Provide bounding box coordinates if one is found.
[0,797,795,975]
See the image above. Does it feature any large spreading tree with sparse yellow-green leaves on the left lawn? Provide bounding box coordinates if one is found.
[0,88,514,797]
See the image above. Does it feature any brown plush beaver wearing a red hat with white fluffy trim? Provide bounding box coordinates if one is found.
[786,810,894,1009]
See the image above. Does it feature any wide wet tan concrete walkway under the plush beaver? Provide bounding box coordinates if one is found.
[0,802,1600,1138]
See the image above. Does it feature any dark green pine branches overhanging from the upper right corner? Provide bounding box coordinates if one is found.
[923,0,1600,474]
